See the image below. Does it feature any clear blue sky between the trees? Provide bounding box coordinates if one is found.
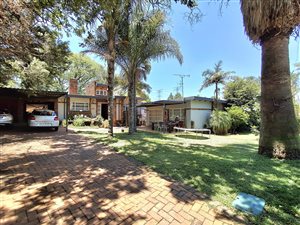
[63,1,300,100]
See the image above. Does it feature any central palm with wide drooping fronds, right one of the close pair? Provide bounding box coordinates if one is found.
[116,9,183,134]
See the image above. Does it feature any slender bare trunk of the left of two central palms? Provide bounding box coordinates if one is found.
[107,32,116,136]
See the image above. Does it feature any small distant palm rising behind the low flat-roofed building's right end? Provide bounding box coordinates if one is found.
[200,60,234,109]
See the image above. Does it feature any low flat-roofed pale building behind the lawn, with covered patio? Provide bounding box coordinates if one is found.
[139,96,226,129]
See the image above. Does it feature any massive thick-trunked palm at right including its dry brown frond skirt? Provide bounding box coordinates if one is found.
[241,0,300,159]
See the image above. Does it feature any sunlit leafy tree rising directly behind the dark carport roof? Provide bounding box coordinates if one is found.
[0,34,70,91]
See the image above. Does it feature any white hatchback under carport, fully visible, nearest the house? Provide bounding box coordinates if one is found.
[28,109,59,131]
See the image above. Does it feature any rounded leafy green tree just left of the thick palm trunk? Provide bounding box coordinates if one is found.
[224,76,260,127]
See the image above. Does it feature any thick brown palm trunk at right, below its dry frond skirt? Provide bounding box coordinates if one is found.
[258,35,300,159]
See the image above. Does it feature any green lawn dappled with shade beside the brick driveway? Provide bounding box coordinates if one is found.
[78,131,300,225]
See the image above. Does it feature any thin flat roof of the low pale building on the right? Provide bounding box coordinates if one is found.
[138,96,227,107]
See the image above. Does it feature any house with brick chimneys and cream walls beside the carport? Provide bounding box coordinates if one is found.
[65,79,126,126]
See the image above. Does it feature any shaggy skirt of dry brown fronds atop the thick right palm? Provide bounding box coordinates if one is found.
[241,0,300,43]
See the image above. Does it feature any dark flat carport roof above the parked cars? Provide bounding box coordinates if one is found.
[0,88,67,98]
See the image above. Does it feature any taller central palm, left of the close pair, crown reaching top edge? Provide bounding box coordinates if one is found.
[83,0,131,136]
